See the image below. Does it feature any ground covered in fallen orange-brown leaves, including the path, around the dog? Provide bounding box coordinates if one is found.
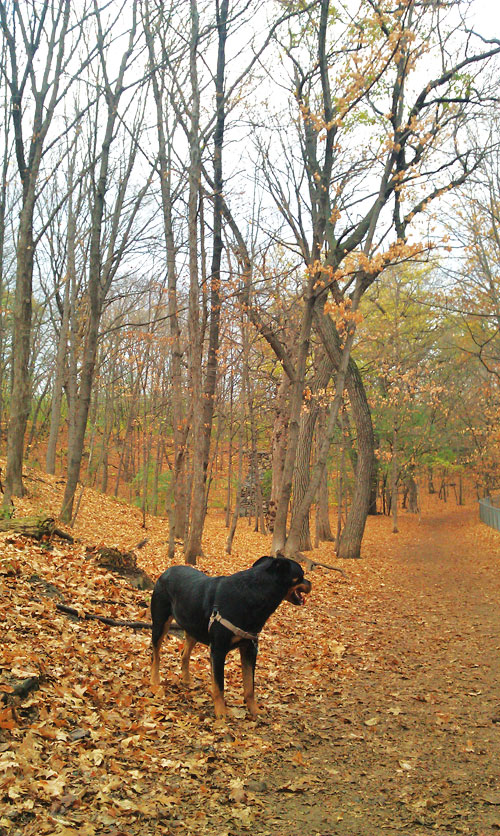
[0,473,500,836]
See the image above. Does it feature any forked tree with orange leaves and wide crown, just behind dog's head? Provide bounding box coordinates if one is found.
[237,0,500,554]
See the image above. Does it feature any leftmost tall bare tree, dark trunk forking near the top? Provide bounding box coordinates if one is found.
[0,0,86,510]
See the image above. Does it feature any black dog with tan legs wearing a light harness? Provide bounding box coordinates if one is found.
[151,557,311,718]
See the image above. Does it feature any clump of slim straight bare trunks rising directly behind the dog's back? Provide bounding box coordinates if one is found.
[144,0,233,563]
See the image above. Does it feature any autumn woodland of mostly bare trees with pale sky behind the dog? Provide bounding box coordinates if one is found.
[0,0,500,562]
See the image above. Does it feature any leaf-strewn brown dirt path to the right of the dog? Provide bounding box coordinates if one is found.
[258,510,500,836]
